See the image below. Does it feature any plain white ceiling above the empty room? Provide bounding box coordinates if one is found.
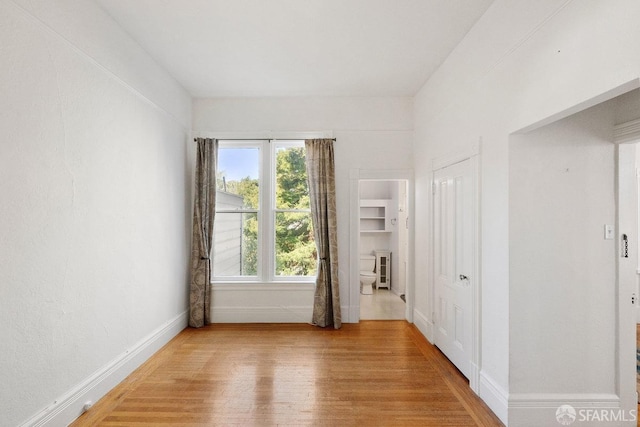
[95,0,493,97]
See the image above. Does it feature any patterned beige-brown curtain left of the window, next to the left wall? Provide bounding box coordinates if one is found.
[189,138,218,328]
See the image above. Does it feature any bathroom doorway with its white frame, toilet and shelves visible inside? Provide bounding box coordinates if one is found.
[349,169,414,323]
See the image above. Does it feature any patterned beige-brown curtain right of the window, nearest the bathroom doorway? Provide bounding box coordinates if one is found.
[305,139,342,329]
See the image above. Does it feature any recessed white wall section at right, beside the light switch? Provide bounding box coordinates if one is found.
[509,100,617,399]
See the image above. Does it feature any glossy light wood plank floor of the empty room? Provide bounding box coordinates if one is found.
[72,321,502,427]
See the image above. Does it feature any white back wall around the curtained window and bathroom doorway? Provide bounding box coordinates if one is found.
[193,98,413,322]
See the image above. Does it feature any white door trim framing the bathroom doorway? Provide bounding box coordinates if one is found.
[348,169,415,323]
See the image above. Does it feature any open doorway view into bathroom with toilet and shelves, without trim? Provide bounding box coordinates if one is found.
[358,180,409,320]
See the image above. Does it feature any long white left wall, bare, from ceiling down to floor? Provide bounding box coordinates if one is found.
[0,0,192,426]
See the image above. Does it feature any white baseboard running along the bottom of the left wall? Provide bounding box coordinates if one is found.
[21,311,188,427]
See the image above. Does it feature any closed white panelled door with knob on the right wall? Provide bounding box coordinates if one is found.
[433,159,476,378]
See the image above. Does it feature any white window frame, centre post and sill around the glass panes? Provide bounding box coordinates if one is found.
[211,138,318,284]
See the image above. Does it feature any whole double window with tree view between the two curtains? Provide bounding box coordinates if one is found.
[213,140,317,282]
